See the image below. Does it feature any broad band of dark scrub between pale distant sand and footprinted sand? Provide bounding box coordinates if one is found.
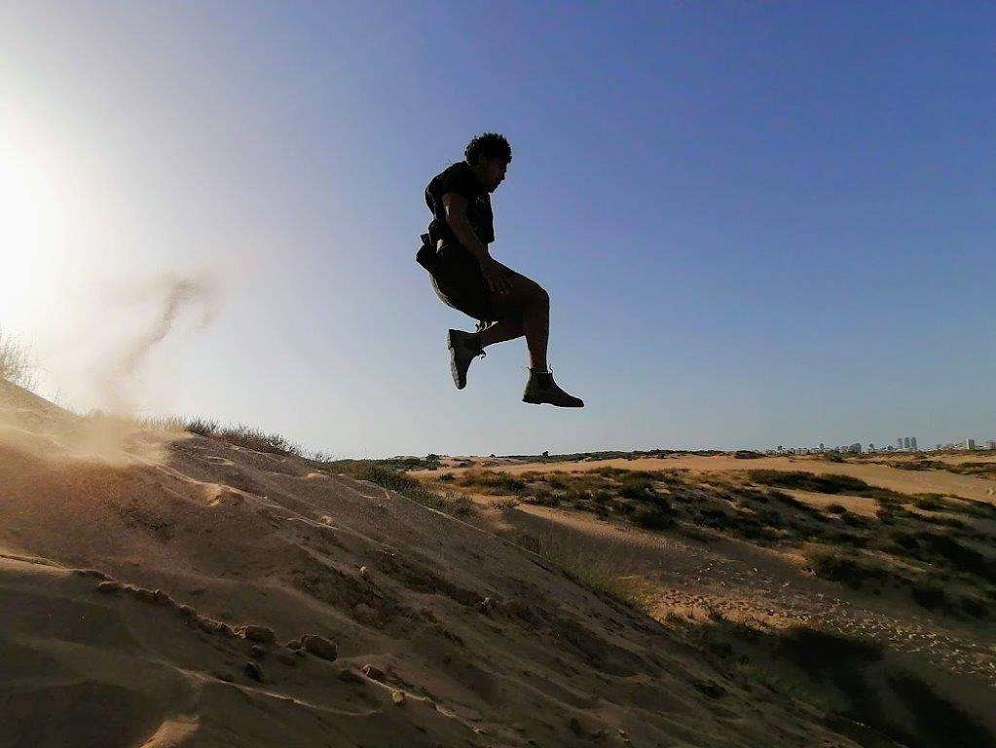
[414,458,996,619]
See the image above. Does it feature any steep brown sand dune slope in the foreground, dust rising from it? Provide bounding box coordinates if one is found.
[0,390,868,748]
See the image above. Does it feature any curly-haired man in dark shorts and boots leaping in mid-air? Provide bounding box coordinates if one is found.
[416,133,584,408]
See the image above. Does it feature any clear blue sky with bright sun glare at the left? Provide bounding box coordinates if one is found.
[0,2,996,457]
